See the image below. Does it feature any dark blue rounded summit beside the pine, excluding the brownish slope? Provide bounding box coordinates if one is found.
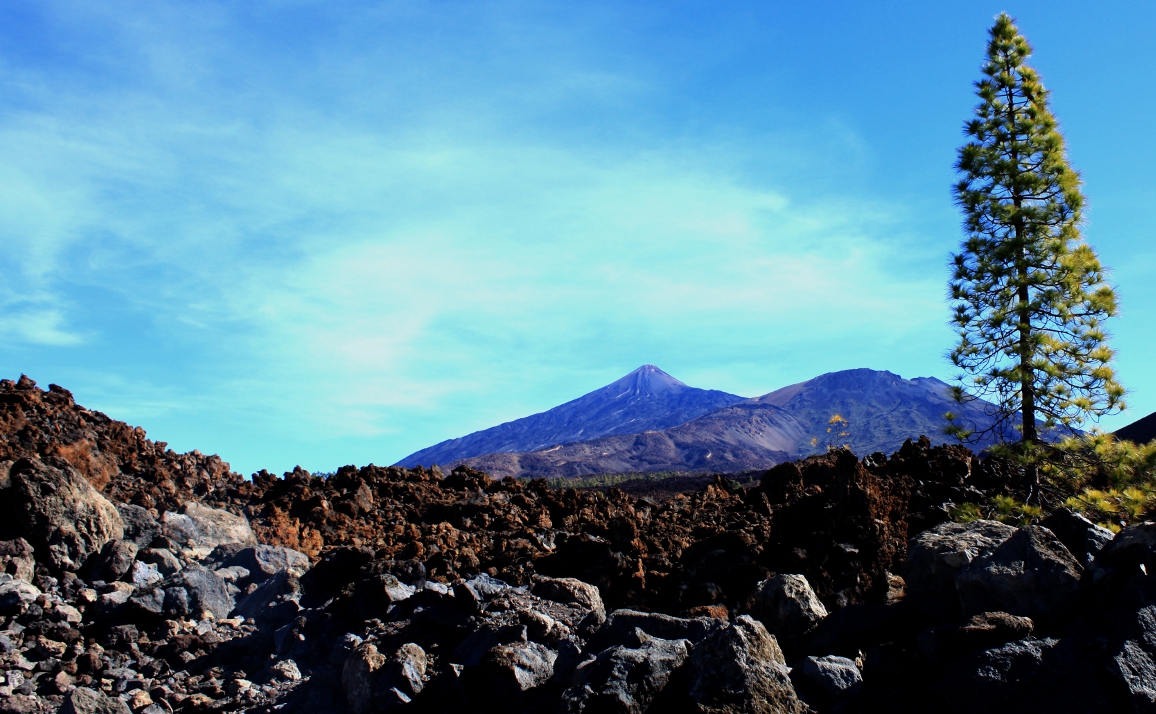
[751,369,1008,454]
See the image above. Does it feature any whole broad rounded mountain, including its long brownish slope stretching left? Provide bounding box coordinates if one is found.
[443,369,1003,477]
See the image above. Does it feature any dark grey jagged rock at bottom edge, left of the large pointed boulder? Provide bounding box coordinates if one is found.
[562,629,689,714]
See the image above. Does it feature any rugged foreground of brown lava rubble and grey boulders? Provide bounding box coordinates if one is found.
[0,379,1156,714]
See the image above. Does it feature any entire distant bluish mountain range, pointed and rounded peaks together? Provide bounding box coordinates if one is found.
[398,365,1012,477]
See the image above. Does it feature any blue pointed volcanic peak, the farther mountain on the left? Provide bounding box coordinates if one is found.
[395,364,743,467]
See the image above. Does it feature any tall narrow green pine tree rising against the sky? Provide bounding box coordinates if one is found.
[949,14,1124,455]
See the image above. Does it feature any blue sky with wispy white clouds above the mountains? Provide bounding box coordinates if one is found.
[0,1,1156,474]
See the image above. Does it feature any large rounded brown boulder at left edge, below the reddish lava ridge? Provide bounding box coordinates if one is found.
[0,459,124,572]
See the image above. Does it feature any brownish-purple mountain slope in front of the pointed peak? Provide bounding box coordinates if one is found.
[450,401,807,478]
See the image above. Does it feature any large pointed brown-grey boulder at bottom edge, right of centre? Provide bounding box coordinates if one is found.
[689,615,807,714]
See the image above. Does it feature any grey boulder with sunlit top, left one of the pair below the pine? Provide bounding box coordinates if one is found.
[903,521,1016,622]
